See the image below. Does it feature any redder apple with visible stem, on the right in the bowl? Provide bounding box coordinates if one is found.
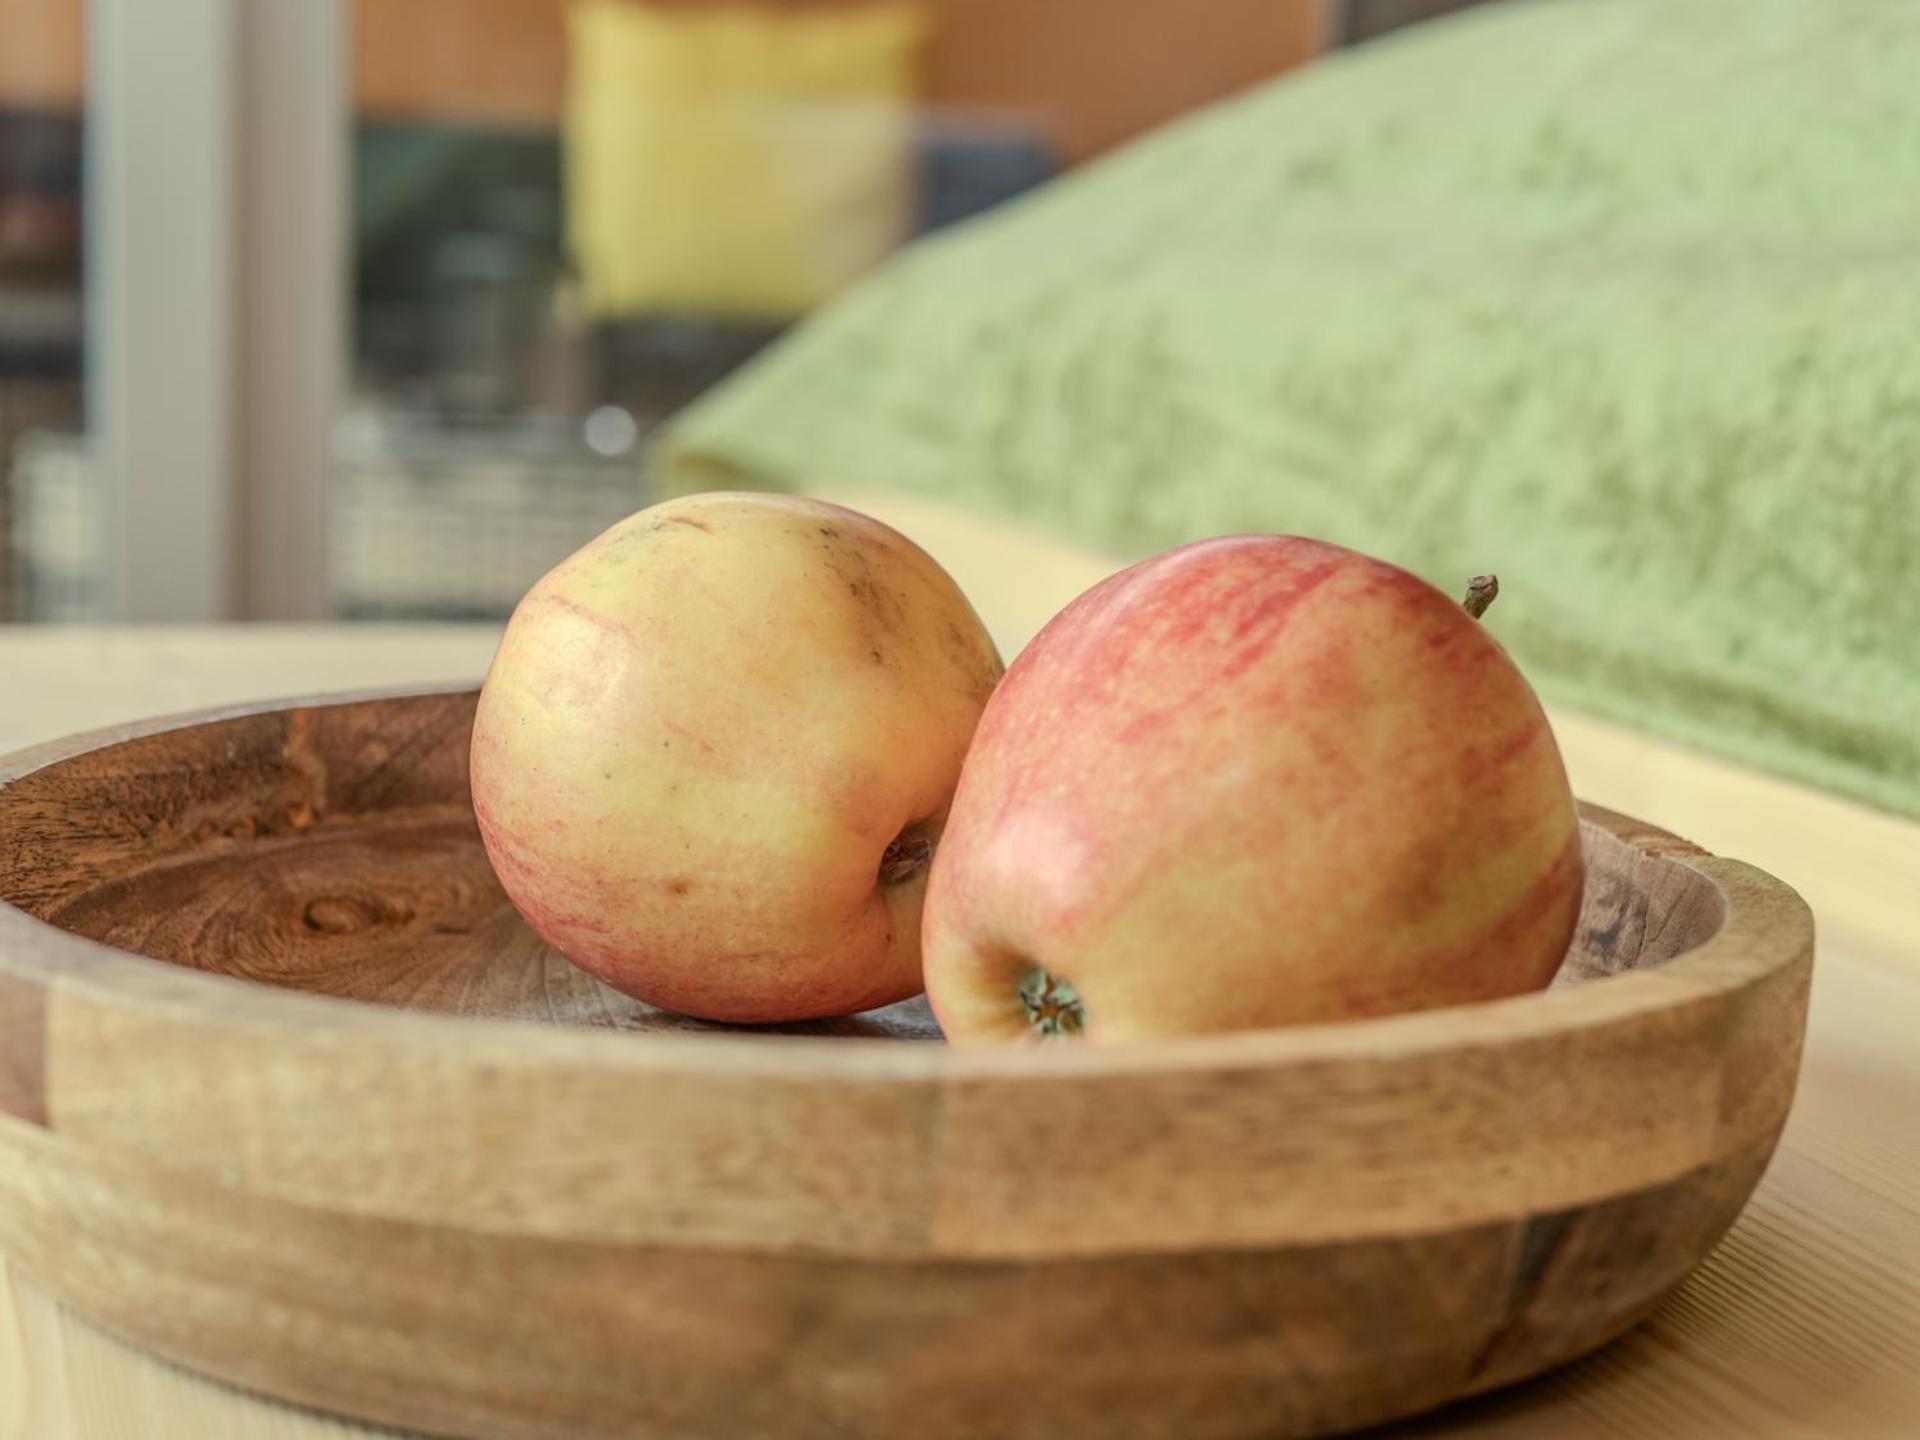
[924,536,1582,1044]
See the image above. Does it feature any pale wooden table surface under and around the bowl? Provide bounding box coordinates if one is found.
[0,499,1920,1440]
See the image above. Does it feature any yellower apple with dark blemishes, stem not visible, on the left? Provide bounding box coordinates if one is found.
[470,493,1002,1023]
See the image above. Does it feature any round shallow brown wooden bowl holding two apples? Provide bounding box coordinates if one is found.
[0,693,1812,1440]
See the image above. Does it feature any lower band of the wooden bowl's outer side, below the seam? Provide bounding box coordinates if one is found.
[0,1135,1768,1440]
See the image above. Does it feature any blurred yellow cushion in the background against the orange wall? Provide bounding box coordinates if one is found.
[566,0,925,319]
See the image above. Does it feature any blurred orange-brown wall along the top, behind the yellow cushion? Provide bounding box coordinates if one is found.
[0,0,1323,157]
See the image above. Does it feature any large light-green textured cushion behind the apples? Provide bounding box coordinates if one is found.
[662,0,1920,814]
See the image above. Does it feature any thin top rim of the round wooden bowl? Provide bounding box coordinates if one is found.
[0,682,1812,1083]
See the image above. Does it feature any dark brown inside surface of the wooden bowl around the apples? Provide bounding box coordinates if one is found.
[0,693,1720,1041]
